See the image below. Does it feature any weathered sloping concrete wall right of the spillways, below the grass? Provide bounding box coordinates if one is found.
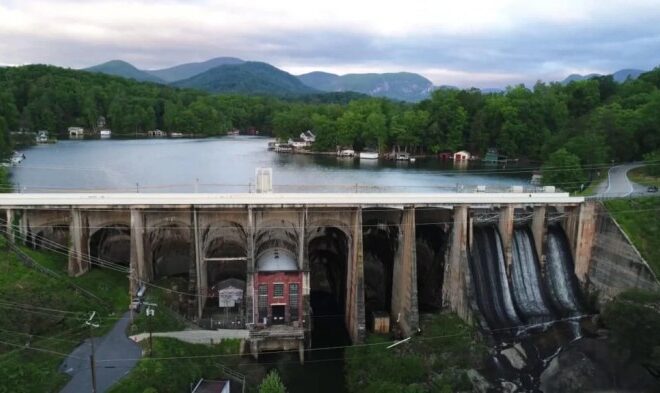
[576,204,660,303]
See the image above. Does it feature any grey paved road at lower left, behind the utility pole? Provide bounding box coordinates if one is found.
[60,312,142,393]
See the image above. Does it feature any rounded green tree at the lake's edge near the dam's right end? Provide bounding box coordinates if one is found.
[541,148,586,191]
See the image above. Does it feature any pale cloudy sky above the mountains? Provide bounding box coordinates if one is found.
[0,0,660,88]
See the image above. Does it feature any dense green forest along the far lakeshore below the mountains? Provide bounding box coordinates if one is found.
[0,65,660,188]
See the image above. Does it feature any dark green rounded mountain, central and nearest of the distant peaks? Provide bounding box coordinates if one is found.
[172,61,318,96]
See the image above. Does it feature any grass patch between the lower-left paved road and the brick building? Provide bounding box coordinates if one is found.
[110,337,240,393]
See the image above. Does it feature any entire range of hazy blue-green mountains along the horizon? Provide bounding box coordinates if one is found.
[85,57,644,102]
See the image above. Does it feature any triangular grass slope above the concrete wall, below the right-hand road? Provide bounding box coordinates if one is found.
[605,197,660,276]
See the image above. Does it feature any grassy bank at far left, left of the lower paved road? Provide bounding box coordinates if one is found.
[0,237,128,392]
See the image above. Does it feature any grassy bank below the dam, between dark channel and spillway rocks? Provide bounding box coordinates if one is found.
[345,314,486,393]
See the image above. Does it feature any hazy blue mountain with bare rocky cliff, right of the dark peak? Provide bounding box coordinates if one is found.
[298,71,433,101]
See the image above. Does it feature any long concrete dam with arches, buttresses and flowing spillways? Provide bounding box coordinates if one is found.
[0,192,658,355]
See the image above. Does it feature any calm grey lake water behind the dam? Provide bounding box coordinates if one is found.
[12,136,531,192]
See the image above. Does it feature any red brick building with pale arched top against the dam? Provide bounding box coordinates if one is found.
[254,248,303,327]
